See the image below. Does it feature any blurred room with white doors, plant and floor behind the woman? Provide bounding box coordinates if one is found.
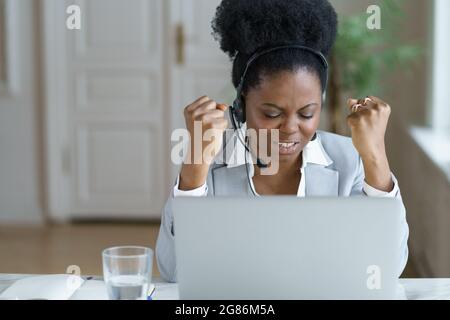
[0,0,450,277]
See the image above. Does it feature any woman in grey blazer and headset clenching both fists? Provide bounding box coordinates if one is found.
[156,0,408,282]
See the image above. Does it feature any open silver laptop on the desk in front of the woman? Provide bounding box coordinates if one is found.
[173,196,404,300]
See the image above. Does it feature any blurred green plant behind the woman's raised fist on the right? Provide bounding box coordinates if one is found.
[328,0,421,132]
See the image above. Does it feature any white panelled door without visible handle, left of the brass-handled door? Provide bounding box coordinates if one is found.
[43,0,169,219]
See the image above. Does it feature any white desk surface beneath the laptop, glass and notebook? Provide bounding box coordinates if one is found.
[0,274,450,300]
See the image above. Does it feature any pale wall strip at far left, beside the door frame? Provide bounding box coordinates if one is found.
[0,0,43,223]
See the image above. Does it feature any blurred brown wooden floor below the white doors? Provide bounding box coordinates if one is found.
[0,223,418,278]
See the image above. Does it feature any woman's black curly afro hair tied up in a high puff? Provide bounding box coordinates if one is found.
[212,0,337,94]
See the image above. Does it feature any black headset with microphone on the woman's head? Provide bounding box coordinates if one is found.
[229,44,328,172]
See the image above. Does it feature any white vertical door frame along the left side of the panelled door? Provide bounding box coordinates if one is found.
[40,0,70,222]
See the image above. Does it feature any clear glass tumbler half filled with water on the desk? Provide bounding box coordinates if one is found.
[102,246,153,300]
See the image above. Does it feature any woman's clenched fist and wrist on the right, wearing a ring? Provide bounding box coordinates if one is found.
[347,96,393,192]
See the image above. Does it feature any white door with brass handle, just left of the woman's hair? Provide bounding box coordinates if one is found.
[170,0,235,178]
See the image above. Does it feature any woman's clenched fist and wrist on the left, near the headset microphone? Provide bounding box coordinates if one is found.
[178,96,228,191]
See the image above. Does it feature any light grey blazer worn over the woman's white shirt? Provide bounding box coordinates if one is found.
[156,131,409,282]
